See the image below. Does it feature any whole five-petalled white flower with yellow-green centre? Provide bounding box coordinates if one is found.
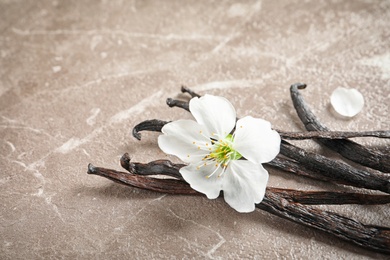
[158,95,280,212]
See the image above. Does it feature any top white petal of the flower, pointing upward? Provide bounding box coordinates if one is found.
[190,95,236,138]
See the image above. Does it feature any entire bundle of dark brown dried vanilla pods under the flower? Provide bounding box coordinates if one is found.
[88,83,390,254]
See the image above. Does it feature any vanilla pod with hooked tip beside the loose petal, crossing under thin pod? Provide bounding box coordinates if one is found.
[290,83,390,173]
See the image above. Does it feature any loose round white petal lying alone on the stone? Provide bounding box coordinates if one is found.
[330,87,364,117]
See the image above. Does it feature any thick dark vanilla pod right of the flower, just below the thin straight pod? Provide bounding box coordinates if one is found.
[280,141,390,193]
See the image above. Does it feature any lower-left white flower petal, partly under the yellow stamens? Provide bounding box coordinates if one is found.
[180,164,223,199]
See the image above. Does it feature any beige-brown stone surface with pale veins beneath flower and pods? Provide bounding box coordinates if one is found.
[0,0,390,259]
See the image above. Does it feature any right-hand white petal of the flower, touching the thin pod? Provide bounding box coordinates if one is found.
[233,116,280,163]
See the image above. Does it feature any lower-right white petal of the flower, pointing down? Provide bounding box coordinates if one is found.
[223,160,268,212]
